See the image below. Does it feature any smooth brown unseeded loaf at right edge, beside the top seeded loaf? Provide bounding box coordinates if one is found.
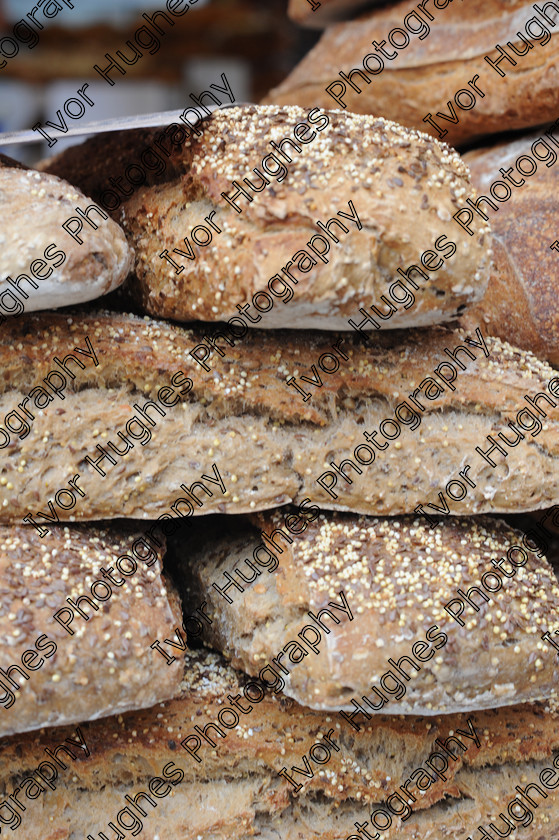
[462,132,559,365]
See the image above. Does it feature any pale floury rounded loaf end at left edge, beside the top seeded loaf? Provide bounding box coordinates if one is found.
[0,166,132,315]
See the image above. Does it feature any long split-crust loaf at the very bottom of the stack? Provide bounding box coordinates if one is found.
[0,653,559,840]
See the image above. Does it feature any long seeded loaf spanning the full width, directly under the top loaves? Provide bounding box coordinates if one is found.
[0,313,559,524]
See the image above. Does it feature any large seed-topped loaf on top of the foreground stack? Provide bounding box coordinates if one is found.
[57,106,490,330]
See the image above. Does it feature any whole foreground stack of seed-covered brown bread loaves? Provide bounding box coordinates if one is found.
[0,80,559,840]
